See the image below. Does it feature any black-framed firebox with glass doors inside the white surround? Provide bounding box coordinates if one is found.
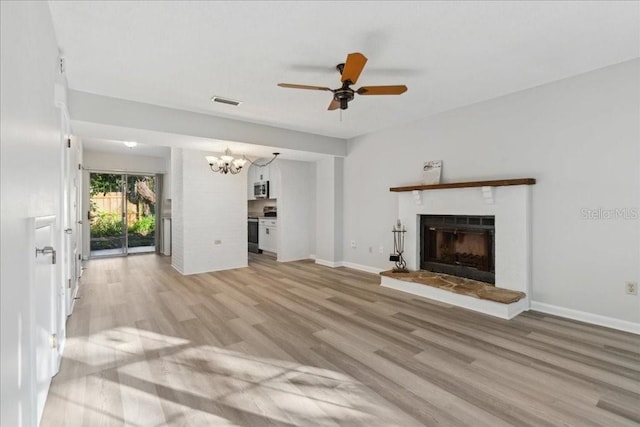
[420,215,496,283]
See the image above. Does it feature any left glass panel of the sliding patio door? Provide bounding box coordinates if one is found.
[89,172,127,257]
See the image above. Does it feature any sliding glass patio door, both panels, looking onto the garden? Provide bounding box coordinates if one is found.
[88,172,157,258]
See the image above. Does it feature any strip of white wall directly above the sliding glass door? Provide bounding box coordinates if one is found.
[82,150,167,174]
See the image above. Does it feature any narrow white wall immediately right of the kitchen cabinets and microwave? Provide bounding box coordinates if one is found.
[271,159,316,261]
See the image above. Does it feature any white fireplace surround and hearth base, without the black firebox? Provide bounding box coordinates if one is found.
[381,181,535,319]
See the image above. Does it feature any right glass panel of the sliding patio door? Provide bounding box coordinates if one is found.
[126,175,156,253]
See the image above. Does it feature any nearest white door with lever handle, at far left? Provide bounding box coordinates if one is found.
[29,216,60,425]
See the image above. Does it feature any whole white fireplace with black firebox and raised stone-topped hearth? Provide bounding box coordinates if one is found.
[390,182,534,319]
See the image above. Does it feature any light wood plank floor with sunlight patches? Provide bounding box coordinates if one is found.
[42,255,640,427]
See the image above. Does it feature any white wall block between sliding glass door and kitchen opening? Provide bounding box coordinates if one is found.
[171,149,247,274]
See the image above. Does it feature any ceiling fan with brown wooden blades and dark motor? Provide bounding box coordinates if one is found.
[278,52,407,110]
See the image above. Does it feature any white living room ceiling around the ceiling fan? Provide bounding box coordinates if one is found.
[49,1,640,138]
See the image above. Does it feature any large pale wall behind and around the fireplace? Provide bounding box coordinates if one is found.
[344,60,640,322]
